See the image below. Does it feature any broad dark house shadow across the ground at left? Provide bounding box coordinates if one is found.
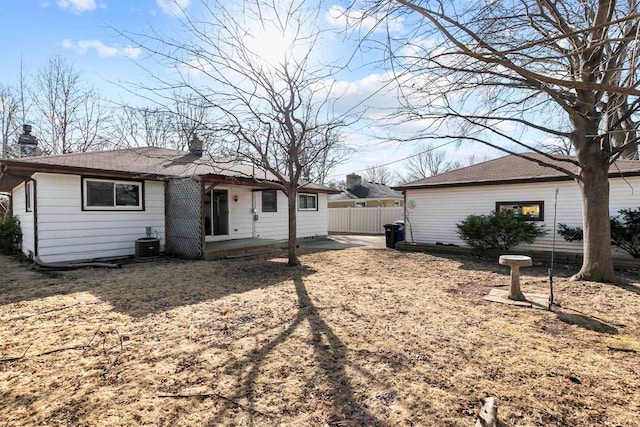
[0,257,314,317]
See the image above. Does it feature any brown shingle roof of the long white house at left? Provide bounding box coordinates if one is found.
[2,147,334,192]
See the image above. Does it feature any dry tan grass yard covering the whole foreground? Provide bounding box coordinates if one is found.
[0,249,640,426]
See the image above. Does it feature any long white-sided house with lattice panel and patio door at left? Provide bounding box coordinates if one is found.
[0,129,335,262]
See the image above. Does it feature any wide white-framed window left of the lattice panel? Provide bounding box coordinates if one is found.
[82,178,143,211]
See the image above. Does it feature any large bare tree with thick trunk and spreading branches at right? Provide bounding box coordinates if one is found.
[356,0,640,282]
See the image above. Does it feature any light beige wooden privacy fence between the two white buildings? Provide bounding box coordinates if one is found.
[327,208,404,234]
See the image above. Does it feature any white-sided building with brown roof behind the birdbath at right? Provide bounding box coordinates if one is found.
[396,153,640,256]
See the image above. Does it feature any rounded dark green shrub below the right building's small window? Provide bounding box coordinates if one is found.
[457,211,546,251]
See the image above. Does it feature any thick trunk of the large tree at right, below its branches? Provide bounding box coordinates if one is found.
[573,150,616,282]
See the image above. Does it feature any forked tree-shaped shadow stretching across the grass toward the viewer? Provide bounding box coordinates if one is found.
[208,271,384,426]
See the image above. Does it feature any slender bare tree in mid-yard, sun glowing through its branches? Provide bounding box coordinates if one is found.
[136,0,344,265]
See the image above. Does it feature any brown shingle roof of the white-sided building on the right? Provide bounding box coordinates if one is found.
[394,153,640,189]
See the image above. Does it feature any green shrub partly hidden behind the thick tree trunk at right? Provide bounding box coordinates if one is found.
[558,208,640,258]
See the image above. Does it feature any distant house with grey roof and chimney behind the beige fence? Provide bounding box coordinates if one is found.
[328,174,404,208]
